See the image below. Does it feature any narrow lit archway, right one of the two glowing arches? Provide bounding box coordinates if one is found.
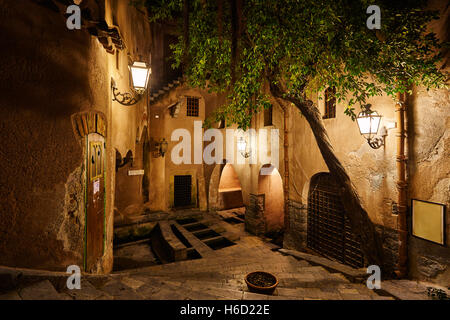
[258,164,284,234]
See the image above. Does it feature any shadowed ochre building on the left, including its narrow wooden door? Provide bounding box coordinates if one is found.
[0,0,151,273]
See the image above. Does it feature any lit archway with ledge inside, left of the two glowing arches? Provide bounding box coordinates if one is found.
[209,163,244,210]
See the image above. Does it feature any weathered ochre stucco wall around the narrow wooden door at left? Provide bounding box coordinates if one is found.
[0,0,150,272]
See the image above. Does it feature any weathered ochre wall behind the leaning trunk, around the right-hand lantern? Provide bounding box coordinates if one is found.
[285,2,450,285]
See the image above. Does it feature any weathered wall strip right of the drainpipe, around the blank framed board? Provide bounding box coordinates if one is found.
[408,88,450,285]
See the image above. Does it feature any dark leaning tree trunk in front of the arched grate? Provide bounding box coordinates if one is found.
[270,81,383,267]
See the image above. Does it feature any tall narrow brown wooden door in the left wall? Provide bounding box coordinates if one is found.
[85,133,105,271]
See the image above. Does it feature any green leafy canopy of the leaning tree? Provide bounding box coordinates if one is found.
[140,0,448,129]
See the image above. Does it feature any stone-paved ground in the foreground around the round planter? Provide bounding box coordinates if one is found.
[0,211,442,300]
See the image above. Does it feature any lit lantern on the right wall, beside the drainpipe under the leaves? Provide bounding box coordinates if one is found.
[356,104,387,149]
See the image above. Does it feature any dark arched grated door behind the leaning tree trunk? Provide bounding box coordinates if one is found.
[307,173,364,268]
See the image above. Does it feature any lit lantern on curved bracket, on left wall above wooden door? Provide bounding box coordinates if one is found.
[111,61,152,106]
